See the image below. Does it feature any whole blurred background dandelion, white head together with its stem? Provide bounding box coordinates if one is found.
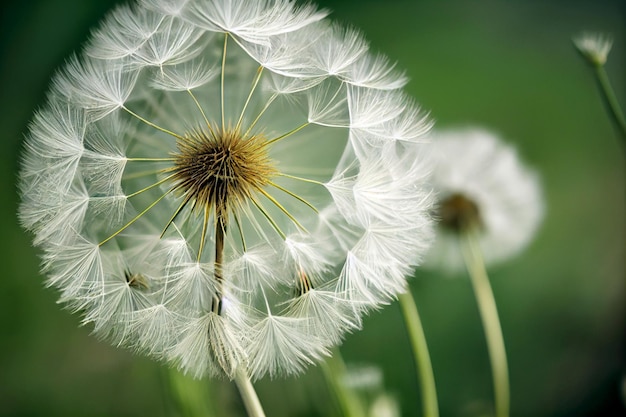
[425,128,544,417]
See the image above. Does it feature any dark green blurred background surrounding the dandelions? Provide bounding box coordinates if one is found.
[0,0,626,417]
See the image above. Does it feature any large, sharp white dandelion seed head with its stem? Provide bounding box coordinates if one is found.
[20,0,431,415]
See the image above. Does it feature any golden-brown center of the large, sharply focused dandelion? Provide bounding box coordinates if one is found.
[173,130,276,221]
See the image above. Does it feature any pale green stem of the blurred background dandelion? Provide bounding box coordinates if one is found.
[461,227,510,417]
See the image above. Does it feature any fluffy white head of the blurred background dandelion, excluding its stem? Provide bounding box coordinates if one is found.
[425,129,543,270]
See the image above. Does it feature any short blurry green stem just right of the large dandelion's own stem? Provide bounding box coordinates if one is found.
[322,348,366,417]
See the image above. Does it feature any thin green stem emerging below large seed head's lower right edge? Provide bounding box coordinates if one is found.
[398,289,439,417]
